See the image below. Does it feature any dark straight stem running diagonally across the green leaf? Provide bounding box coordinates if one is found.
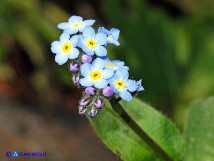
[110,97,173,161]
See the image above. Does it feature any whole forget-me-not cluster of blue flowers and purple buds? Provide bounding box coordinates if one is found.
[51,16,144,117]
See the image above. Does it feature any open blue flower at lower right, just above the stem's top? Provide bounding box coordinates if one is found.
[109,68,138,101]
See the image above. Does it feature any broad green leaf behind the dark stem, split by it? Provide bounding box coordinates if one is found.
[90,98,184,161]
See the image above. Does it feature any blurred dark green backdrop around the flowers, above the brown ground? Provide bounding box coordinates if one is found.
[0,0,214,159]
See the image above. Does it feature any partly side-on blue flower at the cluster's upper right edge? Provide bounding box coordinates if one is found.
[98,27,120,46]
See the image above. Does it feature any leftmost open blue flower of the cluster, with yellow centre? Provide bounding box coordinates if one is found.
[51,33,79,65]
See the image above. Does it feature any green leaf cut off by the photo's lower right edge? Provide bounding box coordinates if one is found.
[185,97,214,161]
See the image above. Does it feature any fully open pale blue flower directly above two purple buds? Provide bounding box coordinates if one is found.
[79,58,114,89]
